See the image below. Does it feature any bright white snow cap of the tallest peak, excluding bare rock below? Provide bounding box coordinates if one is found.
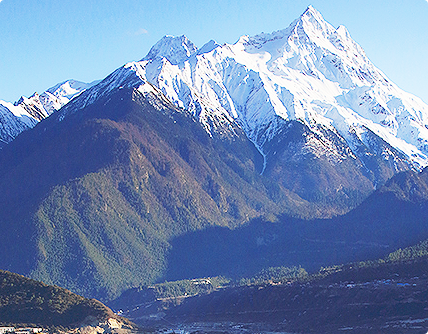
[53,6,428,175]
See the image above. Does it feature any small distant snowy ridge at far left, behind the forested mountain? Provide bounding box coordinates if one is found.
[0,80,98,147]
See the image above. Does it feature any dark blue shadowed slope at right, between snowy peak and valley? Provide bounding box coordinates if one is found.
[161,170,428,280]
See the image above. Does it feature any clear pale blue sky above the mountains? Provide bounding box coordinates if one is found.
[0,0,428,103]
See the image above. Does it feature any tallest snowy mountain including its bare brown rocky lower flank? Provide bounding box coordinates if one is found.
[97,7,428,209]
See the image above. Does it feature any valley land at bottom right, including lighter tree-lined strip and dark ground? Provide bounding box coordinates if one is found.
[111,235,428,334]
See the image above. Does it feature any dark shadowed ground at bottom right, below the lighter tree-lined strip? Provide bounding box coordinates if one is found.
[135,277,428,334]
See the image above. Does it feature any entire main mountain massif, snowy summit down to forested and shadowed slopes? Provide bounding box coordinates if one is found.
[0,7,428,300]
